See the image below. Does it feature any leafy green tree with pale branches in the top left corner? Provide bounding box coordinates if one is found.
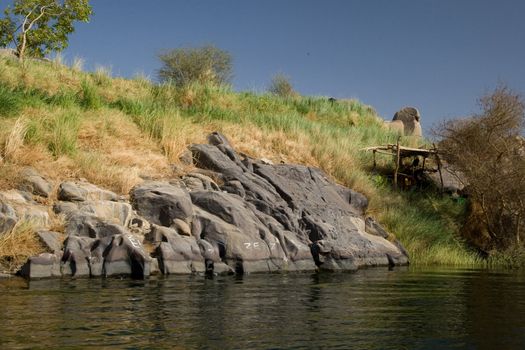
[0,0,92,60]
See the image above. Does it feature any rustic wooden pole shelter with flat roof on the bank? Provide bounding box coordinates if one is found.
[362,139,443,192]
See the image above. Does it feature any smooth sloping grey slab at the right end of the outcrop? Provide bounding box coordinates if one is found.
[255,164,408,270]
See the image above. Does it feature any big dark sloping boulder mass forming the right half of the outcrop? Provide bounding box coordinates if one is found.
[190,133,408,272]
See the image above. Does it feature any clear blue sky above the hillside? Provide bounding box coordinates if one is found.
[9,0,525,129]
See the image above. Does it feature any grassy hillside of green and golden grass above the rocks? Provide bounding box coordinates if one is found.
[0,58,482,266]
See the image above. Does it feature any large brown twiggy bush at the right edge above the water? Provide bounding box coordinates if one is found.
[437,87,525,249]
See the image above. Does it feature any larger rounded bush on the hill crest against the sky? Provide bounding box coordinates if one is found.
[158,45,232,87]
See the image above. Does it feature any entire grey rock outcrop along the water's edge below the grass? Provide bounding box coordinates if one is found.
[0,133,408,278]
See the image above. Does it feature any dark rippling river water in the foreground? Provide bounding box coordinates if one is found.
[0,268,525,349]
